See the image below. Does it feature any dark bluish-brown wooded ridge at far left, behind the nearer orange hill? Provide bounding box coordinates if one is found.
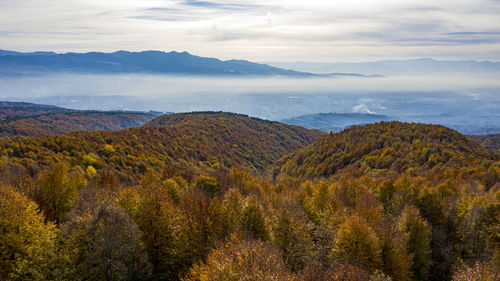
[0,102,156,137]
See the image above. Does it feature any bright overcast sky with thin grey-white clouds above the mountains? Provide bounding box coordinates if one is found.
[0,0,500,62]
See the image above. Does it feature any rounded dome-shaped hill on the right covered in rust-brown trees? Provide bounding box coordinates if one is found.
[274,122,500,177]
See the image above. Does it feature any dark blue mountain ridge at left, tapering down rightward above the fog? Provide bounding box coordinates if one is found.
[0,50,316,77]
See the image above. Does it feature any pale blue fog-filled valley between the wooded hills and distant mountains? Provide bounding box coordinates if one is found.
[0,74,500,133]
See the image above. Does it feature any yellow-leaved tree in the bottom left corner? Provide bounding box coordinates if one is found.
[0,185,57,280]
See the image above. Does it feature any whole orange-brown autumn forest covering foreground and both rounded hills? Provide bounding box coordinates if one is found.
[0,112,500,281]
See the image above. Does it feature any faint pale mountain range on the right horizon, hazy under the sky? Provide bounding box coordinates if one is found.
[268,58,500,76]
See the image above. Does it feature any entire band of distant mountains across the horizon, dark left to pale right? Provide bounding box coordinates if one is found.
[0,50,500,77]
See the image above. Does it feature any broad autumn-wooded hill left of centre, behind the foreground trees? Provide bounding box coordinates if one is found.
[0,113,322,181]
